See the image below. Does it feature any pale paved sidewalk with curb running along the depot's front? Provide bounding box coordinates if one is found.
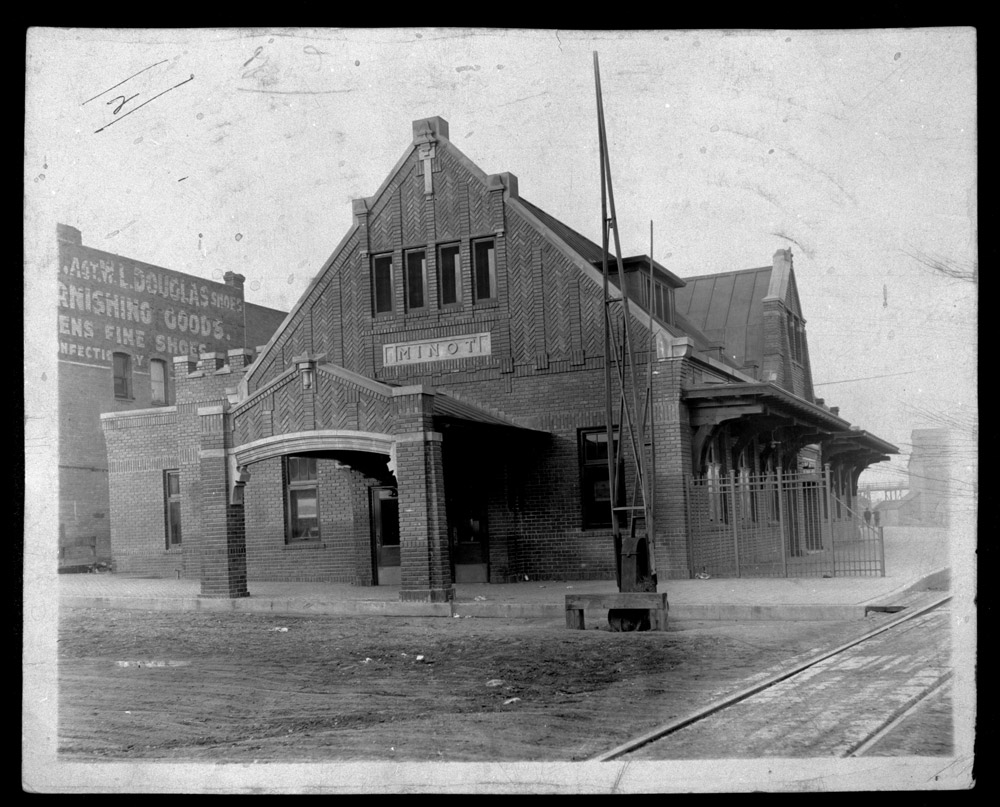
[59,527,950,624]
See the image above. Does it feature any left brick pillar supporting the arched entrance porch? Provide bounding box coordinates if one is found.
[198,406,249,599]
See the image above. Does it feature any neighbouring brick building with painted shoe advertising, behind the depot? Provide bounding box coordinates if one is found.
[57,224,285,570]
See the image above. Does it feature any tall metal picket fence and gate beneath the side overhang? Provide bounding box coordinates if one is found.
[687,467,885,577]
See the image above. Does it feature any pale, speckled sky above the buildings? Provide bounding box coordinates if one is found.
[25,28,978,489]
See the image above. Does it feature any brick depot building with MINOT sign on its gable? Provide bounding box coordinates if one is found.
[102,118,895,601]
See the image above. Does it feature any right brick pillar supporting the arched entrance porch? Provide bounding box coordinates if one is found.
[393,386,455,602]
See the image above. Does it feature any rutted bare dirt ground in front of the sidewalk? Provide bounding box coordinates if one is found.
[59,609,904,762]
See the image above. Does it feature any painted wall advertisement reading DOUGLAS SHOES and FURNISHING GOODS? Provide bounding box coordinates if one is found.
[58,242,244,367]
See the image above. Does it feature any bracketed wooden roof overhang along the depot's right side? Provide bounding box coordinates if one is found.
[681,383,898,470]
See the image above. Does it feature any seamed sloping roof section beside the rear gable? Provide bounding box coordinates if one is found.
[674,266,772,367]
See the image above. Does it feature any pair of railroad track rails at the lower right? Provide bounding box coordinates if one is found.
[591,594,952,762]
